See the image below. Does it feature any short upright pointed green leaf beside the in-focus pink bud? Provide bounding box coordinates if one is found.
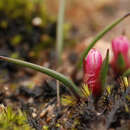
[100,50,109,89]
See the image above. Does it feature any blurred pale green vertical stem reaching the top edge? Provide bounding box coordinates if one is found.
[56,0,66,63]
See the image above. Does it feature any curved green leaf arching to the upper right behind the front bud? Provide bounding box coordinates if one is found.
[78,13,130,67]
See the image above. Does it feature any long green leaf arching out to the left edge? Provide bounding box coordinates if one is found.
[0,56,82,97]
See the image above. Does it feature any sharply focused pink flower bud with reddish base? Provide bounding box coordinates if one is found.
[83,49,102,97]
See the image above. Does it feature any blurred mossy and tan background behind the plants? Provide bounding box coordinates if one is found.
[0,0,130,80]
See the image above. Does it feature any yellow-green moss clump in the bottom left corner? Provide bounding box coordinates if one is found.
[0,105,33,130]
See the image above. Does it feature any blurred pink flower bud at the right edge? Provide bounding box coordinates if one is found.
[111,36,130,73]
